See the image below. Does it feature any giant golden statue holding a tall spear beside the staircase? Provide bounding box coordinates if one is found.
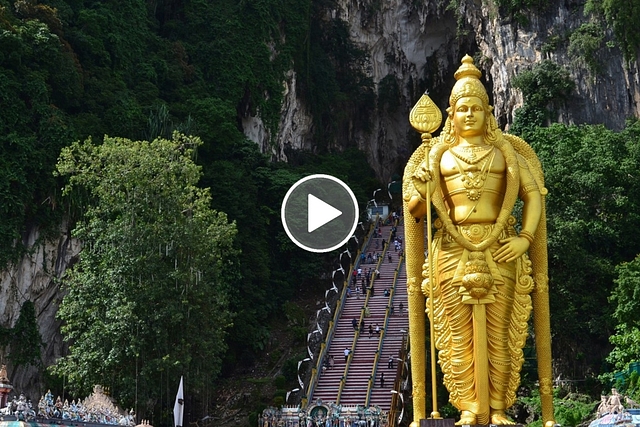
[403,55,555,427]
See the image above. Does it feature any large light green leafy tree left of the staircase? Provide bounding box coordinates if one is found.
[54,133,238,424]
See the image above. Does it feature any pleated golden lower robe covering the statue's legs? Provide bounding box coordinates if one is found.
[422,219,533,414]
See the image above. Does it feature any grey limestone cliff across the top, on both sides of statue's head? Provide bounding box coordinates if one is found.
[245,0,640,182]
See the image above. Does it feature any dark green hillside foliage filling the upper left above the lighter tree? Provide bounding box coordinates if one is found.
[0,0,375,256]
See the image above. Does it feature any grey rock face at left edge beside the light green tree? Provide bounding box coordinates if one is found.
[0,226,80,402]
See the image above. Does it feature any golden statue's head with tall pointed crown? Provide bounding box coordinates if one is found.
[443,55,500,144]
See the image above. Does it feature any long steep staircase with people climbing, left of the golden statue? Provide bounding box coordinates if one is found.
[309,226,409,411]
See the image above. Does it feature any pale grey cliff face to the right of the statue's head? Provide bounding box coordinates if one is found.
[468,0,640,129]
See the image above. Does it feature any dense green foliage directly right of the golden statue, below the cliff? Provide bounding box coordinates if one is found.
[516,122,640,378]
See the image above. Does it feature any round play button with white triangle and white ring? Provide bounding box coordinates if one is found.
[281,174,360,252]
